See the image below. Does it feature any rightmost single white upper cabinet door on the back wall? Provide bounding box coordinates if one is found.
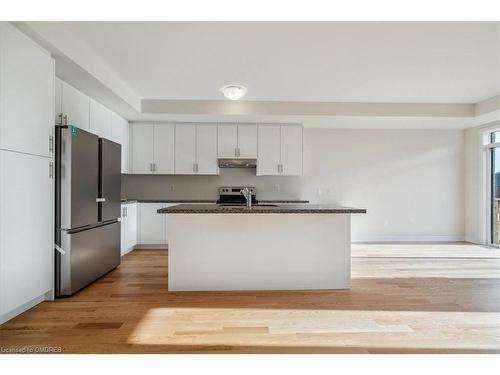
[281,125,302,176]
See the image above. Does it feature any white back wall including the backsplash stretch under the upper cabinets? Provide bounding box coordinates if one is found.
[122,129,465,241]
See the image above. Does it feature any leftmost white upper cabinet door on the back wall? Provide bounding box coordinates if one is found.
[132,124,154,174]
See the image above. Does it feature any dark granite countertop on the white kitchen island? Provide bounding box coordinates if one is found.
[157,204,366,214]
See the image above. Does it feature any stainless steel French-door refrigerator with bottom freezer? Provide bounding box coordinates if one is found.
[54,126,121,297]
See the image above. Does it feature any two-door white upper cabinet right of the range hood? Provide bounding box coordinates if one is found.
[257,125,303,176]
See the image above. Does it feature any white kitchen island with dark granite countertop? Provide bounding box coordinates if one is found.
[158,204,366,291]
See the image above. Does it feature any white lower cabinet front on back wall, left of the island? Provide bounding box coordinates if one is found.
[139,203,166,245]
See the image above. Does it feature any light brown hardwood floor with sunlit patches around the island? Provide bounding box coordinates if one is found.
[0,244,500,353]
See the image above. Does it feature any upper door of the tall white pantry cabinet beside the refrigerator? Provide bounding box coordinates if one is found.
[0,23,54,157]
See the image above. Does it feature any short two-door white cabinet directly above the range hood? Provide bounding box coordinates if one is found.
[218,124,257,159]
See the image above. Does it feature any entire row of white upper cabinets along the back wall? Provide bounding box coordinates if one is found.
[131,123,303,176]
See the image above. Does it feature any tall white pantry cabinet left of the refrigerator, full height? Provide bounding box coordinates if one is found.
[0,22,55,324]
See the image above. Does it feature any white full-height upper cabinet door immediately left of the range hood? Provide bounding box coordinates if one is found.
[196,124,219,174]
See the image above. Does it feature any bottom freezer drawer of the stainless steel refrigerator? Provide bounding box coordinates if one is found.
[56,222,120,296]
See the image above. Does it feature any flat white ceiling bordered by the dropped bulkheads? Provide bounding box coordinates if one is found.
[34,22,500,103]
